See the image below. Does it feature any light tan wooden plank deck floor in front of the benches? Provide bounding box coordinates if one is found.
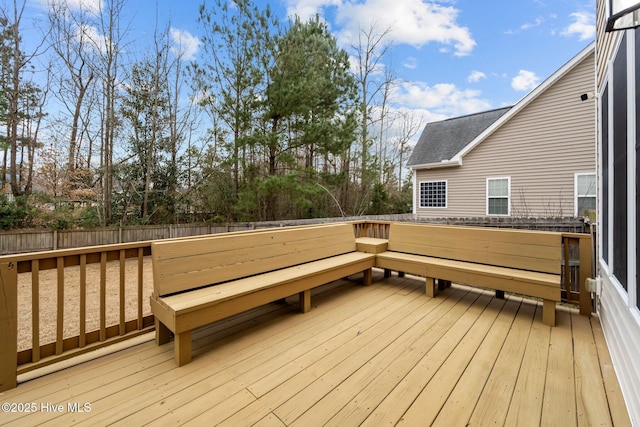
[0,271,630,427]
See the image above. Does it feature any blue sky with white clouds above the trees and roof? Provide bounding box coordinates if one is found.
[27,0,595,125]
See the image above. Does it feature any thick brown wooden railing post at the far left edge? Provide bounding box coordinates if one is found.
[0,261,18,392]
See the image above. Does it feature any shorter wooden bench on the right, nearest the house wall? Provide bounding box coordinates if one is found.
[376,223,562,326]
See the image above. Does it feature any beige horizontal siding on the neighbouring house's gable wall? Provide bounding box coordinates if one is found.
[415,49,596,218]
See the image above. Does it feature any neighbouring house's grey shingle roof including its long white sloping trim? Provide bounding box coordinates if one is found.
[407,42,595,170]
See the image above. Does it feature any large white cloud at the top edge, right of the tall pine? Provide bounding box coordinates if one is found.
[287,0,476,56]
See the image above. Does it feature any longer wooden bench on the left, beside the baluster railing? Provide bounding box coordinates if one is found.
[151,224,375,366]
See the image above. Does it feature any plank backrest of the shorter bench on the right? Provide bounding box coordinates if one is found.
[388,223,562,274]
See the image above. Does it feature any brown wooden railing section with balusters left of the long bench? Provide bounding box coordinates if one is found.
[0,242,153,390]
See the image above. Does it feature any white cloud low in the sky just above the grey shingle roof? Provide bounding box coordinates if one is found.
[394,82,491,119]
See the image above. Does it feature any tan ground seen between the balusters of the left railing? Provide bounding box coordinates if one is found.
[18,257,153,351]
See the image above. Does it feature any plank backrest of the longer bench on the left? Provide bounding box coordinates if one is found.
[151,224,356,296]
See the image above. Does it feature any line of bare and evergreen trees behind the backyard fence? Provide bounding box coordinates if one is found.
[0,0,422,229]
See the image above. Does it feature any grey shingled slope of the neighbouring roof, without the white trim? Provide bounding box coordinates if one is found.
[407,107,511,167]
